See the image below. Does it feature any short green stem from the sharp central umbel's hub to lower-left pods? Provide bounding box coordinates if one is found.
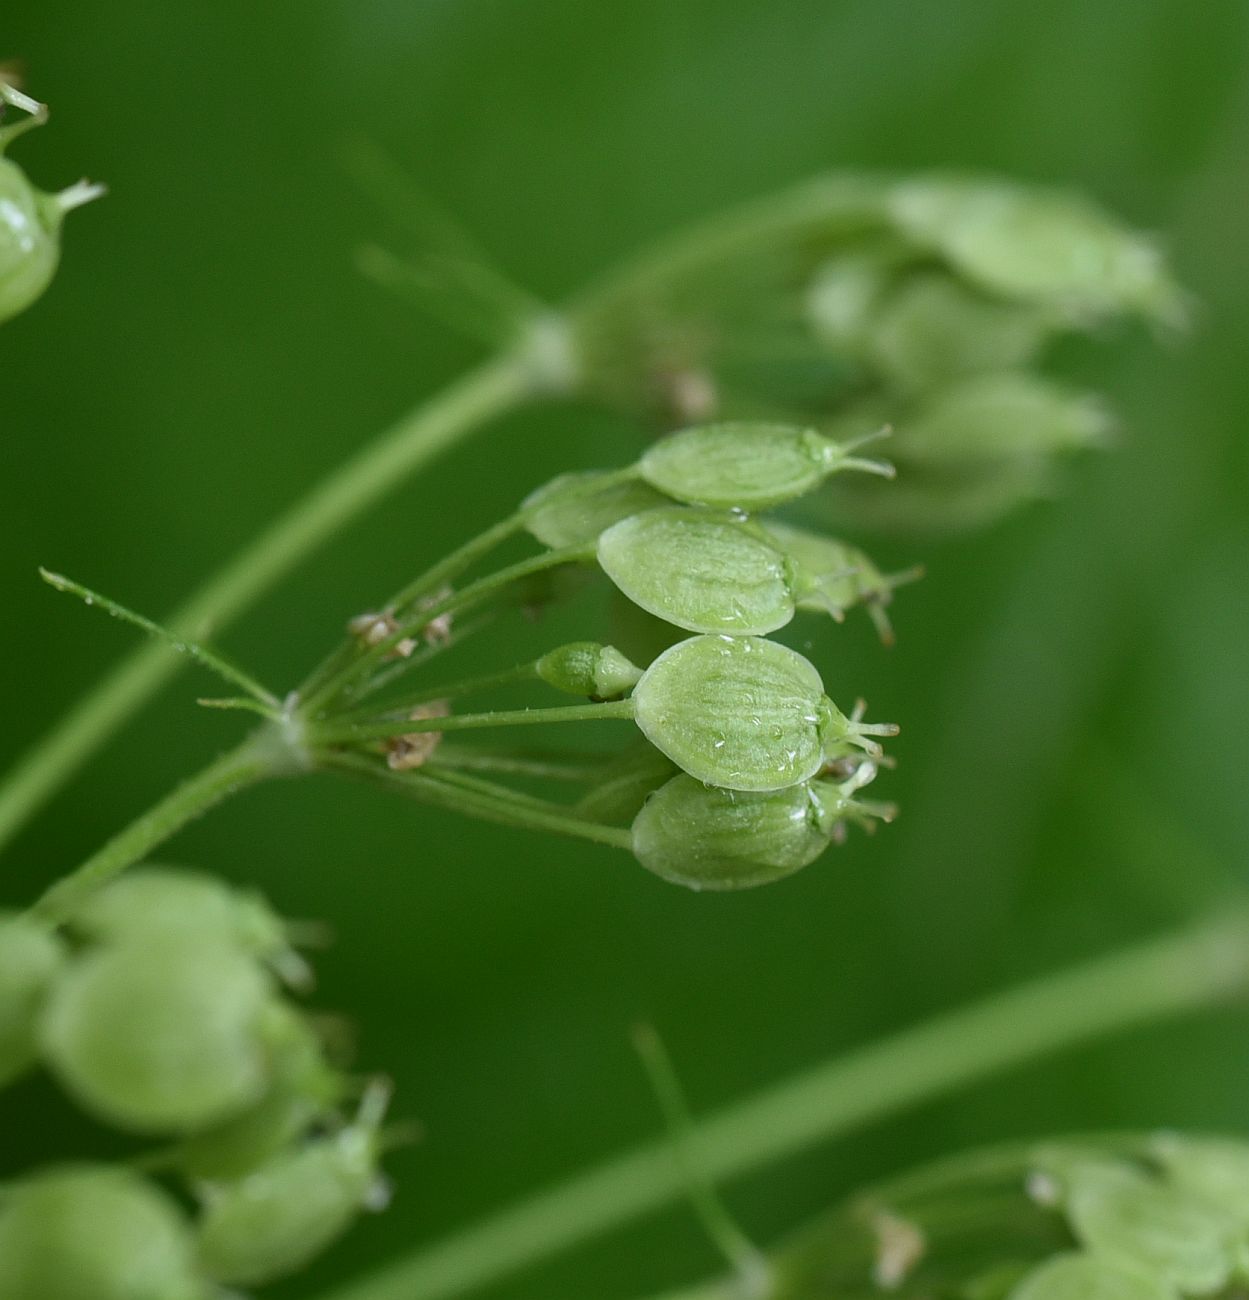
[30,727,291,924]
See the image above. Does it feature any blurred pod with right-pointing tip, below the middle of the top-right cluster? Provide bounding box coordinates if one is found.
[895,372,1113,471]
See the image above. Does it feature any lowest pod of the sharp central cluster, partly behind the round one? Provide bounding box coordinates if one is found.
[633,774,828,889]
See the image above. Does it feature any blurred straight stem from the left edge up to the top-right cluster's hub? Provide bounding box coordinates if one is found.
[0,354,537,863]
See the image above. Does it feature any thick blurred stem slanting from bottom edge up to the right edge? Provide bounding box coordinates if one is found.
[311,913,1249,1300]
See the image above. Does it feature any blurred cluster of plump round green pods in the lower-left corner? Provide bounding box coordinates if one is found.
[0,868,385,1300]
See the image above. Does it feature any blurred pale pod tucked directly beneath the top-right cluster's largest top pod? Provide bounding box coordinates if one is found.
[864,274,1058,391]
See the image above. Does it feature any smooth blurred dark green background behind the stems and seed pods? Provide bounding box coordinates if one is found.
[7,0,1249,1300]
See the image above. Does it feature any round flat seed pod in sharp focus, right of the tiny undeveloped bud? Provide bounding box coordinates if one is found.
[633,636,895,790]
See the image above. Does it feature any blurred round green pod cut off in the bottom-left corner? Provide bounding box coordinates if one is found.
[0,1165,207,1300]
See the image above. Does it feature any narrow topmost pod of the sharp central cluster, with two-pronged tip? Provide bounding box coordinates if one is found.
[638,423,893,510]
